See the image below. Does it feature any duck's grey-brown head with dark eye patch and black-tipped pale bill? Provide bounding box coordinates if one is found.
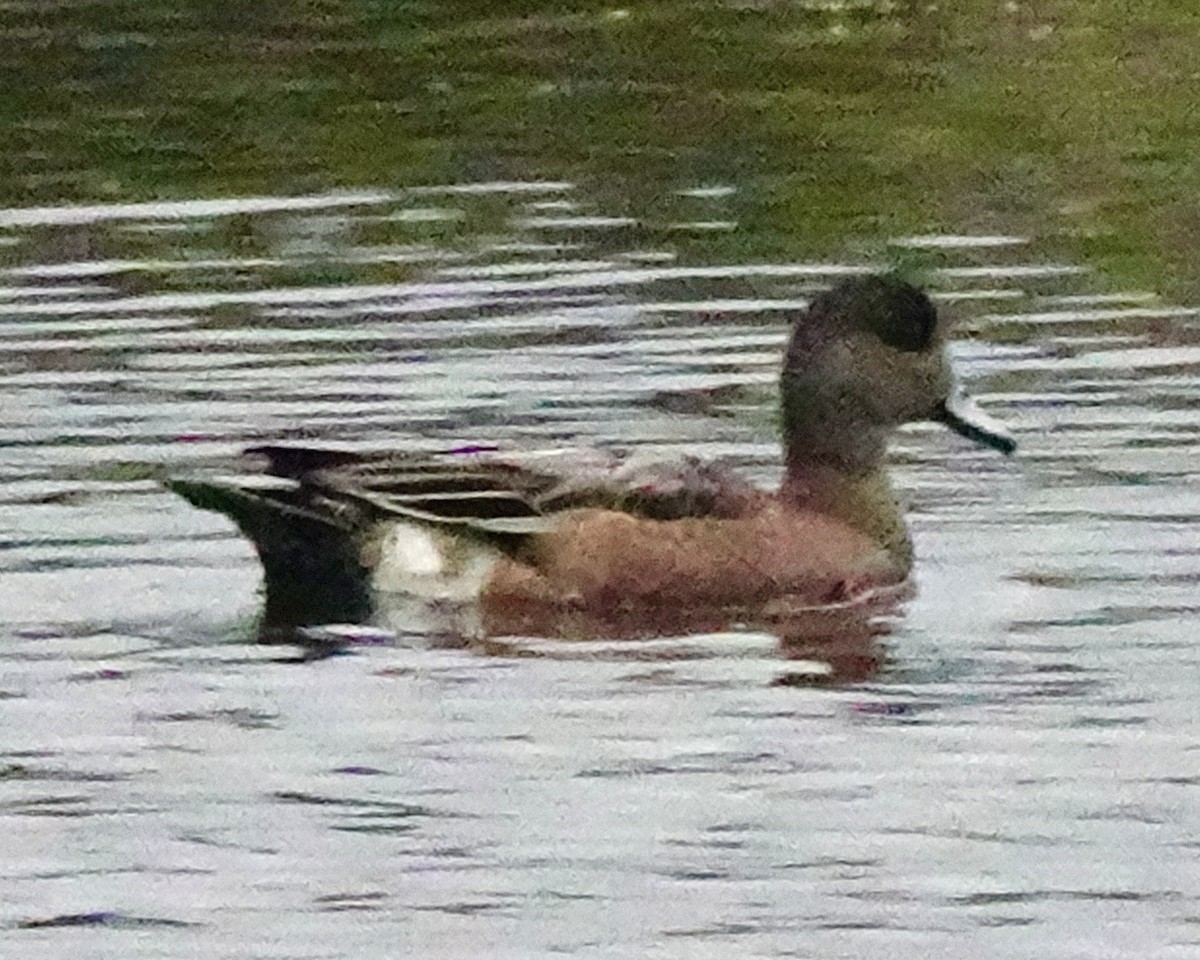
[781,275,1016,473]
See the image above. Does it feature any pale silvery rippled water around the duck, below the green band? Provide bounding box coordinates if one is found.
[0,182,1200,958]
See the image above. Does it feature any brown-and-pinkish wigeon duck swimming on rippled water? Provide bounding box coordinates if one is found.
[169,276,1014,634]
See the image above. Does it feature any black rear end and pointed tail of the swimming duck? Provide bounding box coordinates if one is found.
[167,480,371,625]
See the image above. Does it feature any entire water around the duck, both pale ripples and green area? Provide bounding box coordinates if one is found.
[0,0,1200,960]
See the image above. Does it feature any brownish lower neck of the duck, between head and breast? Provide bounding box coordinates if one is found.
[779,450,912,574]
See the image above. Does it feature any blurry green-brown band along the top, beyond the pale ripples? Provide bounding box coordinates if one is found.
[0,0,1200,296]
